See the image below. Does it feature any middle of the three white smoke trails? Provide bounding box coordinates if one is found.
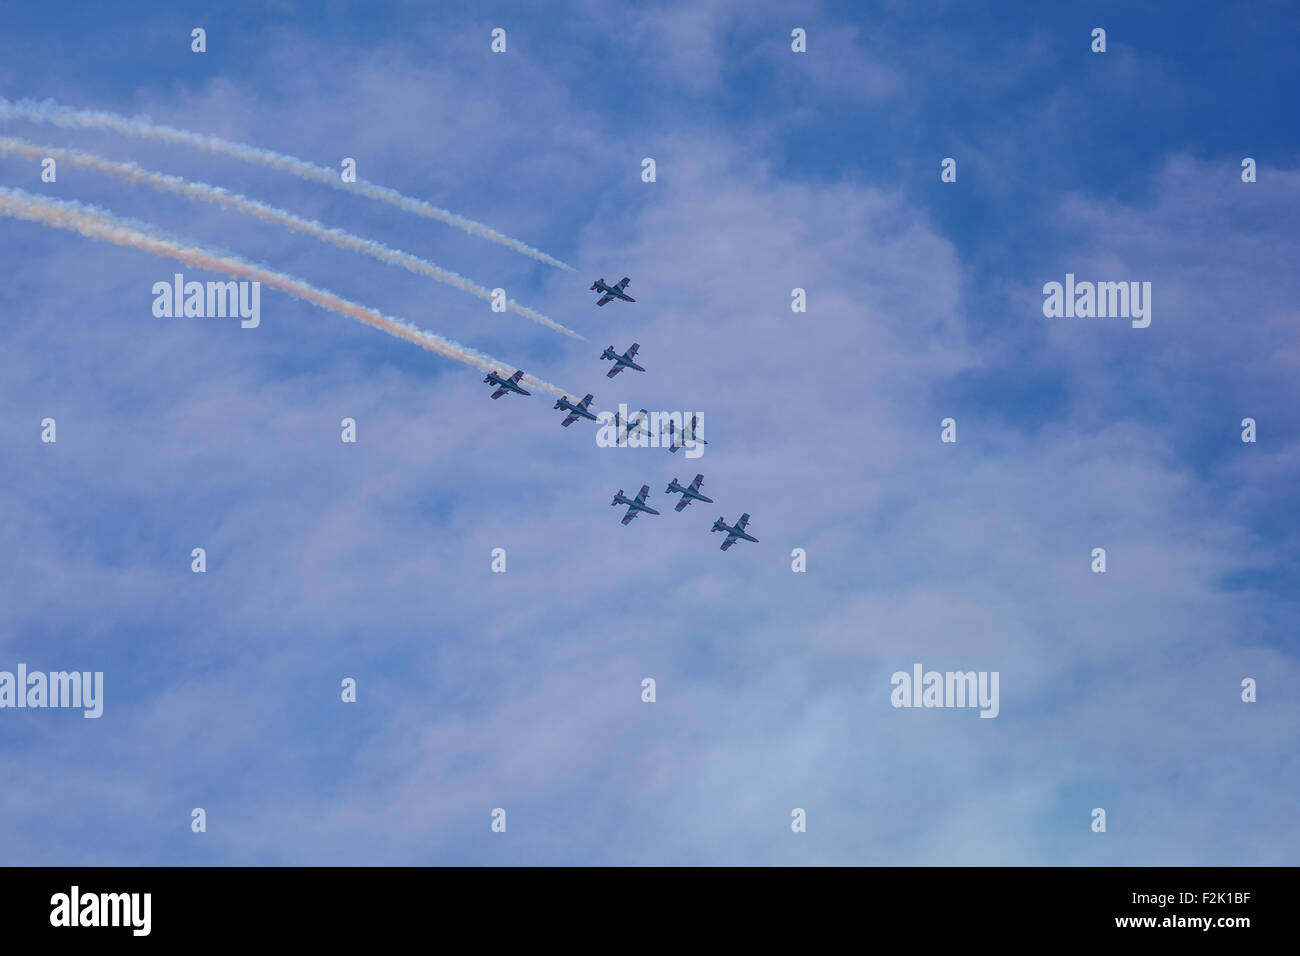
[0,137,586,341]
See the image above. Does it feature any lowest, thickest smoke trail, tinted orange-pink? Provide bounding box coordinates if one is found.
[0,186,573,395]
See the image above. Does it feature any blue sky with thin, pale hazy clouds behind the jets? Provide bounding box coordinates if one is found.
[0,3,1300,865]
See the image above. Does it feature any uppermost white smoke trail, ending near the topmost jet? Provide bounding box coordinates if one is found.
[0,96,573,272]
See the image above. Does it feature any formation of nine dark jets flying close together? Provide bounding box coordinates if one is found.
[484,276,758,551]
